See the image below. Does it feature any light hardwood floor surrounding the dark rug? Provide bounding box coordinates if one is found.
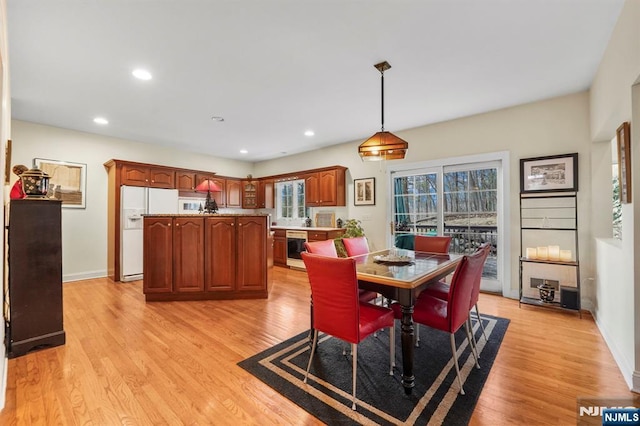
[0,268,632,426]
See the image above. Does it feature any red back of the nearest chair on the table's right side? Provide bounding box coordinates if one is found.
[447,251,486,332]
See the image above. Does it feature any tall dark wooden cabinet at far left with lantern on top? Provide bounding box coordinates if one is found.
[7,199,65,358]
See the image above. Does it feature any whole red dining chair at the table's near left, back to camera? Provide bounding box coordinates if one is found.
[302,253,395,410]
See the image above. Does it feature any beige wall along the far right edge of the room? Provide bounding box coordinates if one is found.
[590,0,640,391]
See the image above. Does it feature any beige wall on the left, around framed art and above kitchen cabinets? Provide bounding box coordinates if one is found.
[12,120,253,281]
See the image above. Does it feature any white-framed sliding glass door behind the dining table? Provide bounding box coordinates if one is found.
[391,161,504,293]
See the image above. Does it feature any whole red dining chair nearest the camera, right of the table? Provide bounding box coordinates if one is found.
[392,251,484,395]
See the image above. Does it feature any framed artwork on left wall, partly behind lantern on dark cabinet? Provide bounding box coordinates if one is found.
[33,158,87,209]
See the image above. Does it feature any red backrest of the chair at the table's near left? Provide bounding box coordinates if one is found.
[302,253,360,343]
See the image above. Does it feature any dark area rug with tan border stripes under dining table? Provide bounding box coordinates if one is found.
[238,315,509,425]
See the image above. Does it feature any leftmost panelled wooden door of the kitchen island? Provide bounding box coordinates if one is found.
[143,217,173,294]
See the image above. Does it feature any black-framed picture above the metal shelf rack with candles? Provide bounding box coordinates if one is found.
[520,153,578,193]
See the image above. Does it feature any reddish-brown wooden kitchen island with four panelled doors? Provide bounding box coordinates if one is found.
[143,214,273,301]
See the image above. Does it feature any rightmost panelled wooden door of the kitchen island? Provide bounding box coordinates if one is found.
[236,216,267,291]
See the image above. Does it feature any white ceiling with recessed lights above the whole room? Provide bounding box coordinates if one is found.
[7,0,624,161]
